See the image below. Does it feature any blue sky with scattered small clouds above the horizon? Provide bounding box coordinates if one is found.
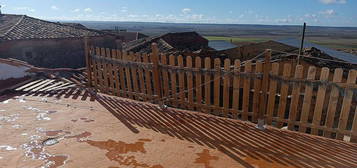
[0,0,357,27]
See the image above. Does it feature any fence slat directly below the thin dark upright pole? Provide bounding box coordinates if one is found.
[288,65,303,130]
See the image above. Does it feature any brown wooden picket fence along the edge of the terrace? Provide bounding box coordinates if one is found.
[86,42,357,142]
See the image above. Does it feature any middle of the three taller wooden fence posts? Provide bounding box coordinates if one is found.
[151,43,162,103]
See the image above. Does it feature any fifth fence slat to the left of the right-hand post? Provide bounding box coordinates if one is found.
[213,58,221,115]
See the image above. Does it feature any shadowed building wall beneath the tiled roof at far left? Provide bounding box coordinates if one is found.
[0,36,118,68]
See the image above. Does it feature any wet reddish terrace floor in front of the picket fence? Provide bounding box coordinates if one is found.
[0,92,357,168]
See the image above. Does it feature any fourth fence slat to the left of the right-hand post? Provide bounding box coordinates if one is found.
[223,59,231,117]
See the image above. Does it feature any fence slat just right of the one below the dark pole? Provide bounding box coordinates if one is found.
[299,66,316,133]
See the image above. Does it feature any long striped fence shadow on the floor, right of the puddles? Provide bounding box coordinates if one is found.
[96,95,357,168]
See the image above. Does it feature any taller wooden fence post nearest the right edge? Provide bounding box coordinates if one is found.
[257,49,271,129]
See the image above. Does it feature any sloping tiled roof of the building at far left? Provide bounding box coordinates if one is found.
[0,14,105,41]
